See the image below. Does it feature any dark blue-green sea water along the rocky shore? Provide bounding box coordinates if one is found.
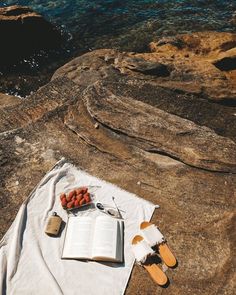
[0,0,236,95]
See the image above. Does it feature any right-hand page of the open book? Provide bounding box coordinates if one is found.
[92,216,120,260]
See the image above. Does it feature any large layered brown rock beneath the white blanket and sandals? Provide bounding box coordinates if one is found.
[0,33,236,295]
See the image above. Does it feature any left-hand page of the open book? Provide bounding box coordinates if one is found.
[62,217,94,259]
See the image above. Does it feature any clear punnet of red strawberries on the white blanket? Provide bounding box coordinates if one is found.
[60,186,93,210]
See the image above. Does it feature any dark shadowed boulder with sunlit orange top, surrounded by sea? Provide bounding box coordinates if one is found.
[0,5,61,66]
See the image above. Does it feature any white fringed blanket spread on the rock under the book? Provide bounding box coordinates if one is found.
[0,160,155,295]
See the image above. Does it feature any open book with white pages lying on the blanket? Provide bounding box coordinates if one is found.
[62,216,124,262]
